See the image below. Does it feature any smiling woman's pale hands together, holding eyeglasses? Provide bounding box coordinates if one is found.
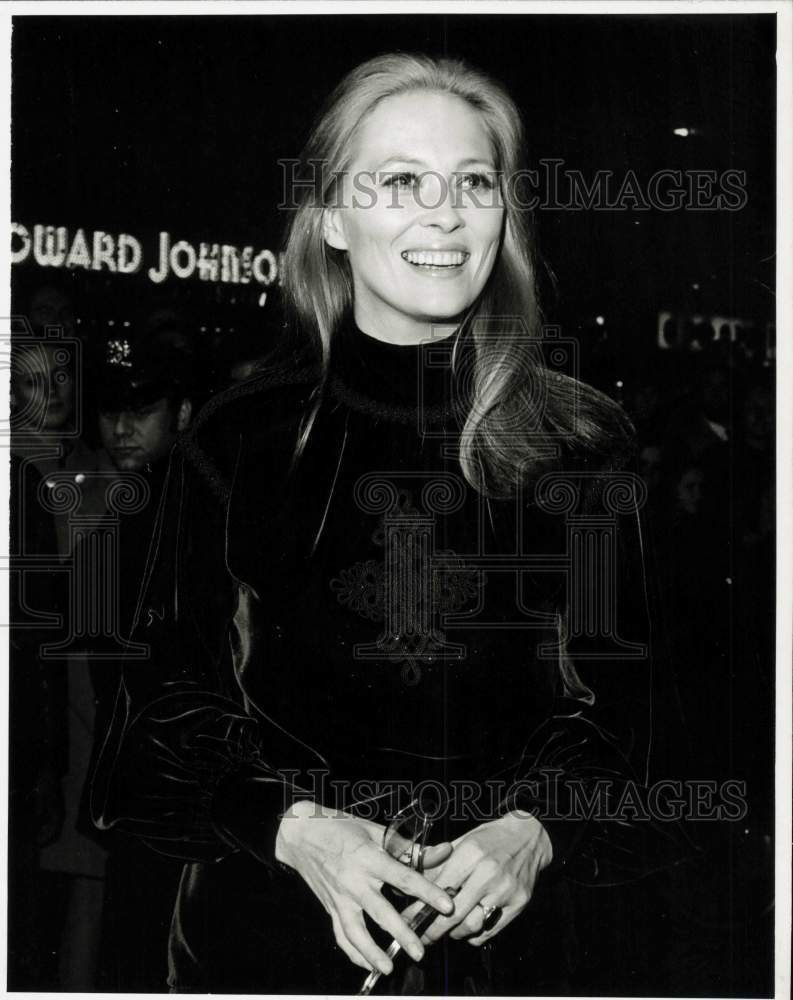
[276,800,552,975]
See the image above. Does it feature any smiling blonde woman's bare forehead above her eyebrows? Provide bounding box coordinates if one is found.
[353,91,494,169]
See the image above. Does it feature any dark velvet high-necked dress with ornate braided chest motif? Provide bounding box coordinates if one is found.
[93,324,672,994]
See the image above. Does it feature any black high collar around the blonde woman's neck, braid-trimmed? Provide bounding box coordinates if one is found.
[328,322,464,423]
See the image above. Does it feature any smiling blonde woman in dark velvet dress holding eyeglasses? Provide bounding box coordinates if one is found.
[94,54,664,993]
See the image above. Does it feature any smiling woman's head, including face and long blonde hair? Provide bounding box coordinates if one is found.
[283,54,630,495]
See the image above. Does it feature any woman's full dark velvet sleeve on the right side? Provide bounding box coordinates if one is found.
[504,471,691,885]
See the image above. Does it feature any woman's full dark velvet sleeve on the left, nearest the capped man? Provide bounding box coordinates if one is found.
[91,382,316,864]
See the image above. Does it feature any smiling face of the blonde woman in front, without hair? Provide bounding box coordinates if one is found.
[325,91,504,343]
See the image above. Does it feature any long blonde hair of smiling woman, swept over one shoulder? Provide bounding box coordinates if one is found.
[283,53,632,496]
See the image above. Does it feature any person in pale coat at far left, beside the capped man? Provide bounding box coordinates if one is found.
[11,296,116,991]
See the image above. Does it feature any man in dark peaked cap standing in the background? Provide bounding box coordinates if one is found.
[85,311,199,993]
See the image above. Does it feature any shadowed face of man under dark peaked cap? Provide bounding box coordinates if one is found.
[99,398,191,472]
